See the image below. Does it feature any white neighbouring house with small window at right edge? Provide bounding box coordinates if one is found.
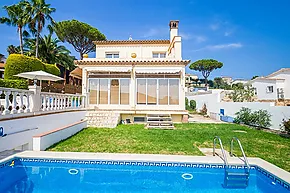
[250,68,290,106]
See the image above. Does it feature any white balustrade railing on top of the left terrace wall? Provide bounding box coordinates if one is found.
[0,86,85,118]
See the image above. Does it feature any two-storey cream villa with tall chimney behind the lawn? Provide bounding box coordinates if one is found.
[75,21,190,123]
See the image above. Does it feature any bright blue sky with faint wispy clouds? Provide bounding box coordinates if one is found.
[0,0,290,78]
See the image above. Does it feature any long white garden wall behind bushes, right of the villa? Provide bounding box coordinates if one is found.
[187,94,290,130]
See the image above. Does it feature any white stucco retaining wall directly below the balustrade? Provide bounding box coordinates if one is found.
[0,111,86,152]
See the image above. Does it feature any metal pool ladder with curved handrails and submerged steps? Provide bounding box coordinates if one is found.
[213,136,250,188]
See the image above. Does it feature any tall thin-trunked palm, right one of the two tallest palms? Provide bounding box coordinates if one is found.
[26,0,56,58]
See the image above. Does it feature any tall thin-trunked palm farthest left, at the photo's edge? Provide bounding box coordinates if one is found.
[0,1,29,54]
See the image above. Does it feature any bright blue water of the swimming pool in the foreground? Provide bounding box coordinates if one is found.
[0,159,290,193]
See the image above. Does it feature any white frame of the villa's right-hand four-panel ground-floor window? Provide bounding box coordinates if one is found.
[135,78,181,106]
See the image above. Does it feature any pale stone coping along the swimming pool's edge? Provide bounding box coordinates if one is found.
[0,151,290,184]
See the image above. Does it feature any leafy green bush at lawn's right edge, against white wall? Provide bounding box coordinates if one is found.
[234,107,271,128]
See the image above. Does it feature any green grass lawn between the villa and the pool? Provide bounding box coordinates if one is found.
[48,124,290,171]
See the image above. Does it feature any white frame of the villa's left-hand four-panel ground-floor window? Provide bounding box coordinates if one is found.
[87,78,131,106]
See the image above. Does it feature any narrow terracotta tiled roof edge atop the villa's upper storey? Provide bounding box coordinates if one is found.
[94,40,170,45]
